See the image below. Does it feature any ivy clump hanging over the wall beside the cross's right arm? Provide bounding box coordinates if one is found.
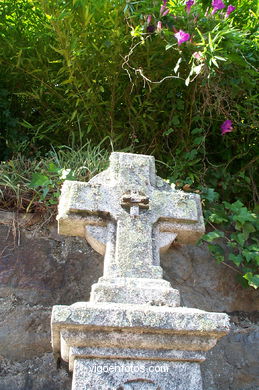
[202,200,259,288]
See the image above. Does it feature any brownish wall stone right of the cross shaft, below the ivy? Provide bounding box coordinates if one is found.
[161,244,259,312]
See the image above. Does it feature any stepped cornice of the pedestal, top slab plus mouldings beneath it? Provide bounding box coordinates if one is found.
[51,302,229,378]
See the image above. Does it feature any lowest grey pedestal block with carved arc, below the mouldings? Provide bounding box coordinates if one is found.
[72,359,202,390]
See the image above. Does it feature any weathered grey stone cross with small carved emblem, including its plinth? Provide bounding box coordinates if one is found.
[58,153,204,305]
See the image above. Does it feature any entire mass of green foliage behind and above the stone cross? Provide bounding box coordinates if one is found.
[0,0,259,286]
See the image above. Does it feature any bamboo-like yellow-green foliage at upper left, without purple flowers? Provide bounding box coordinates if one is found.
[0,0,130,155]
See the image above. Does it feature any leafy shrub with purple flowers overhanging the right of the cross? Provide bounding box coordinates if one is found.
[125,0,258,206]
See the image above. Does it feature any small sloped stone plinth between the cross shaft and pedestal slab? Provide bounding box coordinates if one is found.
[90,277,180,307]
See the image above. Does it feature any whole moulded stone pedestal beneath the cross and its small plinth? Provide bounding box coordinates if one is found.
[52,302,229,390]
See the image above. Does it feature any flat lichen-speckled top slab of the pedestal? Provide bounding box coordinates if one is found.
[51,302,229,337]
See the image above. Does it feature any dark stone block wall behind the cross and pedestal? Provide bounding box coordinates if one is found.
[0,213,259,390]
